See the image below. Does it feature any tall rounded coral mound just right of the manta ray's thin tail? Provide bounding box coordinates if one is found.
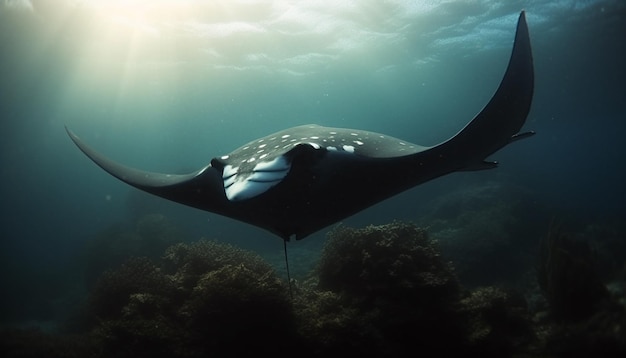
[296,222,462,356]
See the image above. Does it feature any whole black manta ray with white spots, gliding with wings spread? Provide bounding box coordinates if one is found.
[68,12,534,241]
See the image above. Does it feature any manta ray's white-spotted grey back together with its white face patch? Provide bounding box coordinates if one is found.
[211,124,426,201]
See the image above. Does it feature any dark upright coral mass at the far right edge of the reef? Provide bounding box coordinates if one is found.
[537,223,626,357]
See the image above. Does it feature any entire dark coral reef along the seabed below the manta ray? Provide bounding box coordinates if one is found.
[0,217,626,358]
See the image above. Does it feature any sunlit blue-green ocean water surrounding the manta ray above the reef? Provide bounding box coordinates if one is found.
[0,0,626,356]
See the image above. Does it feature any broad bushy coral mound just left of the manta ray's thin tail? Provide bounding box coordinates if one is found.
[90,241,294,357]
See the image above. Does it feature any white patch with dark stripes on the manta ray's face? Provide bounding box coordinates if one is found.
[222,156,291,201]
